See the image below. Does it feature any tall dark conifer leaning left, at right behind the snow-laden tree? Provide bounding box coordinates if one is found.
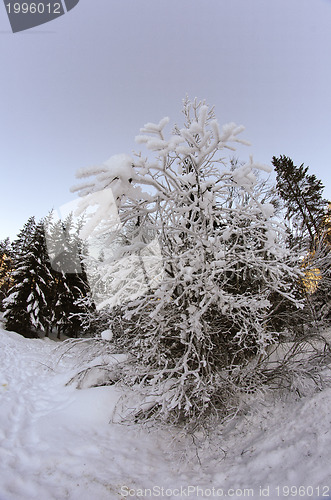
[272,156,331,325]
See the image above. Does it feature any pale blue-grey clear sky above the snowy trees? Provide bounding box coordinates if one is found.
[0,0,331,239]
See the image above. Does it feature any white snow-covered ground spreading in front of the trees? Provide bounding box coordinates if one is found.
[0,318,331,500]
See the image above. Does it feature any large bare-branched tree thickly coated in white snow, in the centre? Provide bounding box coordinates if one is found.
[74,100,300,421]
